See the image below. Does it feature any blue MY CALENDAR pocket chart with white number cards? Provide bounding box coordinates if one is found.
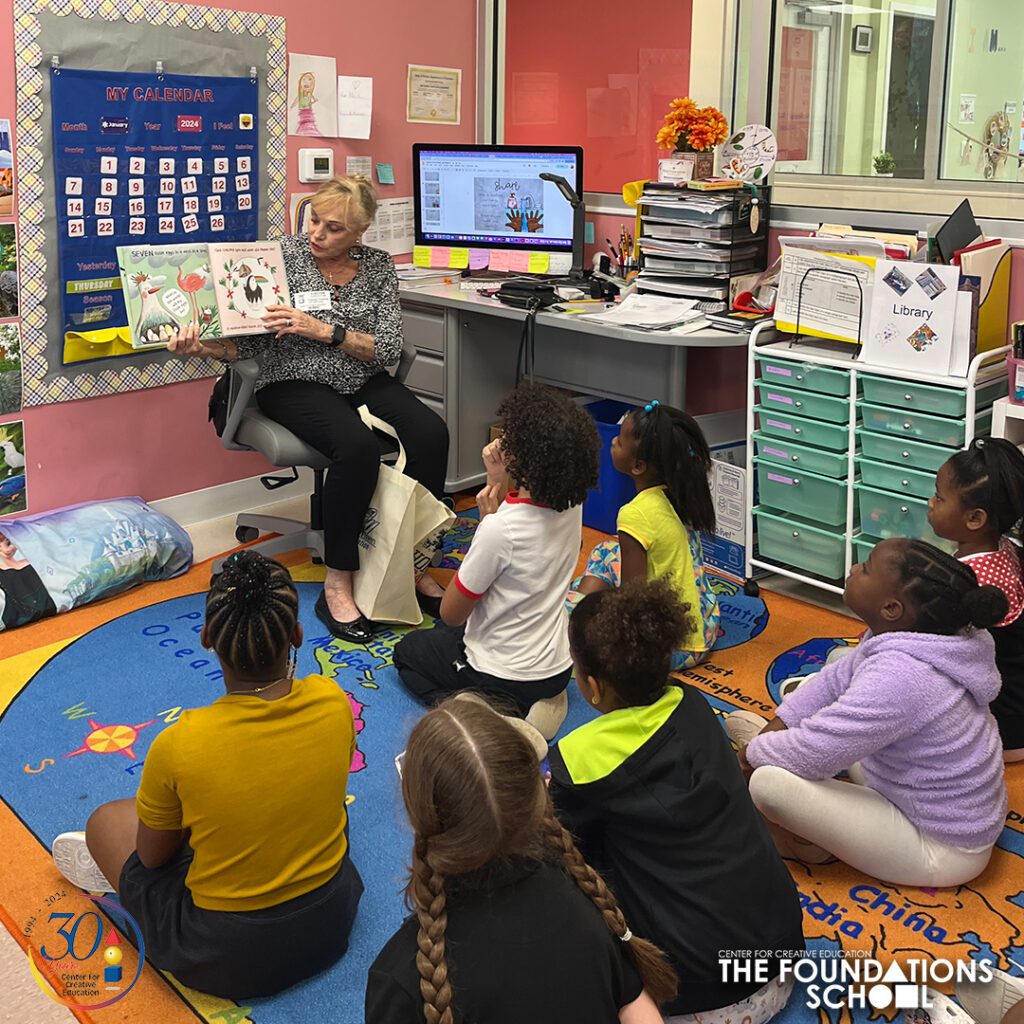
[50,68,259,366]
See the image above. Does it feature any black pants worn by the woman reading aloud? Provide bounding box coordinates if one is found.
[256,373,449,571]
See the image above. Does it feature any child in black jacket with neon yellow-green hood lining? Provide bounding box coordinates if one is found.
[551,581,804,1024]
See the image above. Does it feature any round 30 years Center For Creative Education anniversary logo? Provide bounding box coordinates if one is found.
[24,889,145,1010]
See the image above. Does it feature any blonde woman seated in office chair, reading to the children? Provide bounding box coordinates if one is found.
[168,174,449,643]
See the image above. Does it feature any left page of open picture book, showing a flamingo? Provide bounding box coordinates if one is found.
[118,244,221,348]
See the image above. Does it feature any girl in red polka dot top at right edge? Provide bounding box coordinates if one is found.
[928,437,1024,762]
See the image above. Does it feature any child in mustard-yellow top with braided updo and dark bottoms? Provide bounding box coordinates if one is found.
[53,551,362,999]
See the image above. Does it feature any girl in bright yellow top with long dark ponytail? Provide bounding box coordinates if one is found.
[568,400,721,672]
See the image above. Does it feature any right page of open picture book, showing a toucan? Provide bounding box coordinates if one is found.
[209,242,292,338]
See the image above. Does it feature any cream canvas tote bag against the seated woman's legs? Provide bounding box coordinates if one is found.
[352,406,455,626]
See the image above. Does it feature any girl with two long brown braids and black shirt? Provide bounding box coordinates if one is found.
[365,695,676,1024]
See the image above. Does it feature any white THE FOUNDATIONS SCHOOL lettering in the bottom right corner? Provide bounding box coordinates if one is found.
[718,949,993,1011]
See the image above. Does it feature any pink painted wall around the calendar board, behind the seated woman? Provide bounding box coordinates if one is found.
[0,0,476,512]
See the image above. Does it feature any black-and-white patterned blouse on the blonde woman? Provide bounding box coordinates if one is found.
[231,234,402,394]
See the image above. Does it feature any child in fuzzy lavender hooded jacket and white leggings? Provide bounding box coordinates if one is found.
[729,540,1007,887]
